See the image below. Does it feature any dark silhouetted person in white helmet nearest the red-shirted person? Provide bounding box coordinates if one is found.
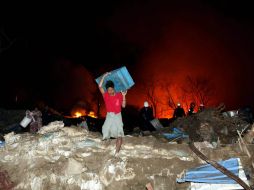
[139,102,155,134]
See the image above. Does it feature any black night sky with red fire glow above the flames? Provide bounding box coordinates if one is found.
[0,0,254,114]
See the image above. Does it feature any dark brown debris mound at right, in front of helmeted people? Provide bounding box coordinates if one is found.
[171,108,250,144]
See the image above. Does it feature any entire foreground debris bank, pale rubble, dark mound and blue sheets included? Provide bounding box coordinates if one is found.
[0,104,254,190]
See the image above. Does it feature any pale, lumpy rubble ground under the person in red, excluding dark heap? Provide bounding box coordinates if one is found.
[0,121,254,190]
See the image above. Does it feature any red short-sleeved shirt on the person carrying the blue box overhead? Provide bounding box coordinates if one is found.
[103,92,123,114]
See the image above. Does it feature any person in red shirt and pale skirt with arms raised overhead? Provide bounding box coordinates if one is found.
[99,73,127,156]
